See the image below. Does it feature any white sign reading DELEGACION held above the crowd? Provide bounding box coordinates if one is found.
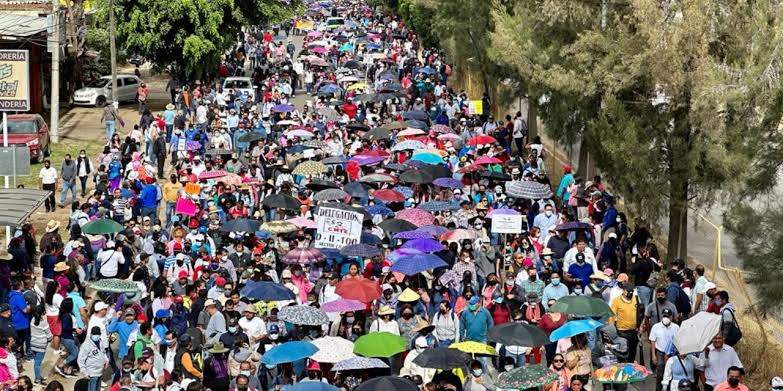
[315,207,364,249]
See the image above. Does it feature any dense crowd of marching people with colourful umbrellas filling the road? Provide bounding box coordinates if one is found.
[0,0,783,391]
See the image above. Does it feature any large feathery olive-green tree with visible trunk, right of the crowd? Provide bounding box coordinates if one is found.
[492,0,781,259]
